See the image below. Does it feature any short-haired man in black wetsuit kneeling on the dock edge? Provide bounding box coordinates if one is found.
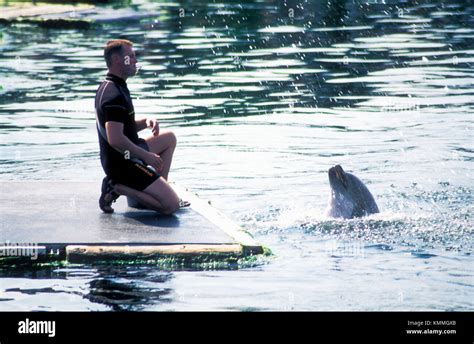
[95,40,188,214]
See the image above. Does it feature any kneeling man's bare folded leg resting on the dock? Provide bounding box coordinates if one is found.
[114,177,179,215]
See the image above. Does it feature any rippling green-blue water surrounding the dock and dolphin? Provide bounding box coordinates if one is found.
[0,0,474,310]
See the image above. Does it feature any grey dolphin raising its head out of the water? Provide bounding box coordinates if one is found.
[327,165,379,219]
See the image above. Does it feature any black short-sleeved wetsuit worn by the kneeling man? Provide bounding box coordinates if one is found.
[95,73,159,191]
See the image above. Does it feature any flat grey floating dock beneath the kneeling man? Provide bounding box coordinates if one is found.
[0,181,263,262]
